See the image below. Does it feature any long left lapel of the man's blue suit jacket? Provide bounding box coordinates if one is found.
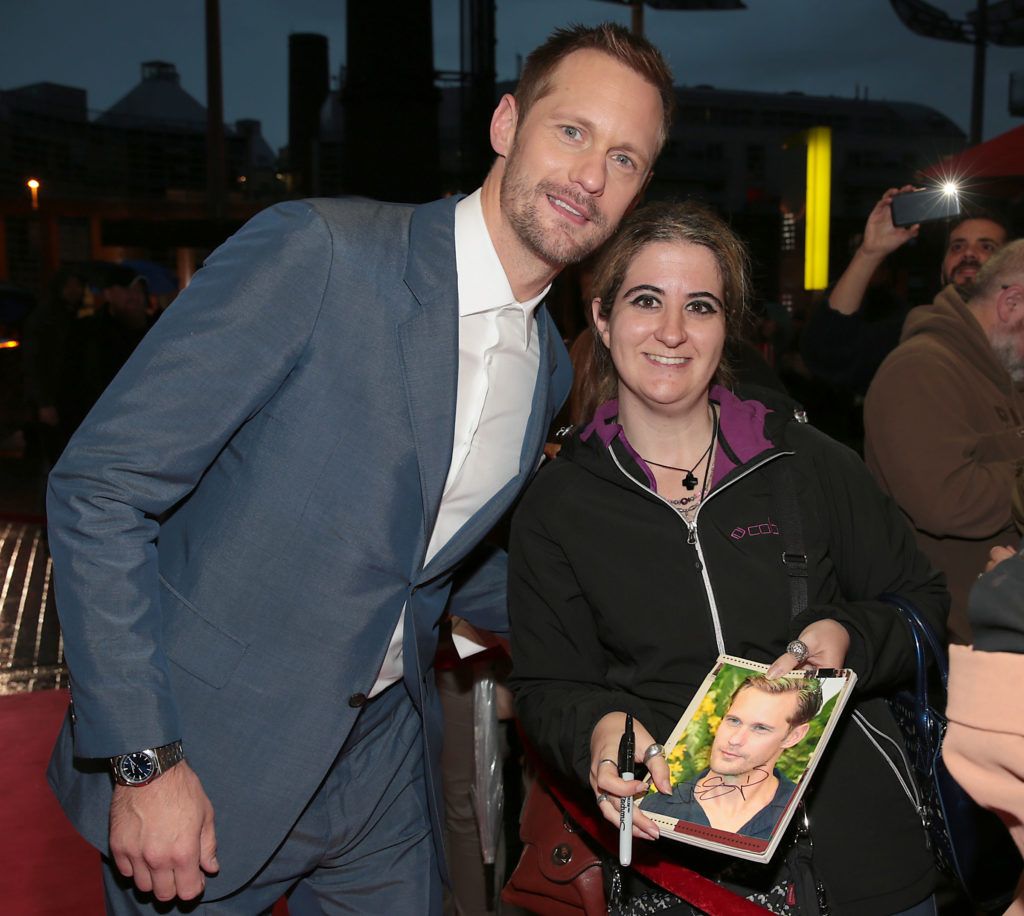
[398,198,459,569]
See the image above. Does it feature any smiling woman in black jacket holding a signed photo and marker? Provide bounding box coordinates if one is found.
[509,204,948,916]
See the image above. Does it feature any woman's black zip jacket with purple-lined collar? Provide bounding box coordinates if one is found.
[509,388,948,916]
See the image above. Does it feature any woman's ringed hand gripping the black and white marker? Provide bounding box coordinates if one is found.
[590,712,672,839]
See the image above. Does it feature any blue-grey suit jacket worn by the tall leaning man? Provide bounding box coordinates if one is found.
[48,199,570,899]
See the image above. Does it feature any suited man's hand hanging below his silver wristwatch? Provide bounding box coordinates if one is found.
[111,760,220,901]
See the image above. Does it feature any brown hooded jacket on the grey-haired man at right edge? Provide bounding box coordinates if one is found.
[864,286,1024,644]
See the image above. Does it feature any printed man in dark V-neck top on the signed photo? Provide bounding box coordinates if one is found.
[642,674,821,839]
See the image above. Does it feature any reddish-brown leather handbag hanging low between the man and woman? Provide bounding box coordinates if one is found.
[502,781,608,916]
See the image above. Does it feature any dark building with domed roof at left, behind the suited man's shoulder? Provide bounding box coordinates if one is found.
[0,60,283,290]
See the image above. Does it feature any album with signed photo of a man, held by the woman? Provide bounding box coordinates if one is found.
[637,655,857,862]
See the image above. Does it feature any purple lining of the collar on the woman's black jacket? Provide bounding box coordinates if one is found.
[580,385,772,492]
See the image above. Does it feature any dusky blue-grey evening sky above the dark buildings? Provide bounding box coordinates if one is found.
[0,0,1024,147]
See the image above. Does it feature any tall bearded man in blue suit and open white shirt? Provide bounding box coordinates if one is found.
[48,26,672,916]
